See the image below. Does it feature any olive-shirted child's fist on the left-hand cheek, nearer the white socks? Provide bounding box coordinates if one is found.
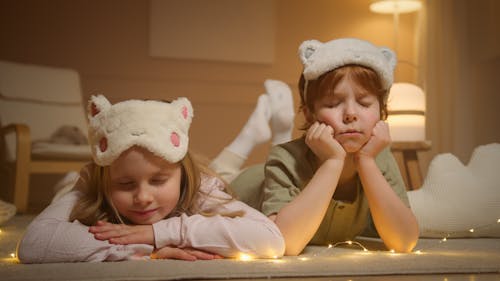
[306,122,346,163]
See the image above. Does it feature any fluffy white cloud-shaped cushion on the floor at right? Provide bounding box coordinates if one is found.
[408,143,500,238]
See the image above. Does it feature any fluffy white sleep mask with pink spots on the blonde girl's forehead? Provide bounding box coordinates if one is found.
[88,95,193,166]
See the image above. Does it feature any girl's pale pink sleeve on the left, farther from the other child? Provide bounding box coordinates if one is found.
[17,188,153,263]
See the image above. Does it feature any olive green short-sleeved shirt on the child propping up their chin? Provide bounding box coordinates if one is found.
[231,137,410,245]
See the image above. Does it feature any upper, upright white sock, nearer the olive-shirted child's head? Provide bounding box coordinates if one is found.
[264,80,295,145]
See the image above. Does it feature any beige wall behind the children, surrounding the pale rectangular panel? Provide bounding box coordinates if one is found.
[0,0,416,163]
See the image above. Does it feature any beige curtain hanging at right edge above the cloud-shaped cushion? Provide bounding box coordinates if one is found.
[423,0,500,168]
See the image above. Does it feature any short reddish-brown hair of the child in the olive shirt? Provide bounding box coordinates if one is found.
[299,65,388,130]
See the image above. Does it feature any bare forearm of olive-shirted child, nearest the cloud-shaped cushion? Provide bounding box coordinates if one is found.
[358,158,419,252]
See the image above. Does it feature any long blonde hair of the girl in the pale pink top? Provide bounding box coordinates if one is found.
[70,151,242,226]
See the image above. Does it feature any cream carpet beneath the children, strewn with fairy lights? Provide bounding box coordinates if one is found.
[0,213,500,280]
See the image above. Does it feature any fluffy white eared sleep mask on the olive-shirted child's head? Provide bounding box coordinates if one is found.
[299,38,397,89]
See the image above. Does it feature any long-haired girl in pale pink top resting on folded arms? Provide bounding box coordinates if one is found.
[18,96,284,263]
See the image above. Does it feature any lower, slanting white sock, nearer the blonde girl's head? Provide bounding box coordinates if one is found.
[227,94,271,159]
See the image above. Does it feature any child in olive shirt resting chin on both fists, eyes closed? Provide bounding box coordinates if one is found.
[231,38,418,255]
